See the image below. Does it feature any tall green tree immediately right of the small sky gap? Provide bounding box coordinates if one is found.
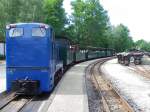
[71,0,108,47]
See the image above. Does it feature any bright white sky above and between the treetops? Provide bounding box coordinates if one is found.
[64,0,150,41]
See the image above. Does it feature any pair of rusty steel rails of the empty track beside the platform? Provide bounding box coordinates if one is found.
[90,58,134,112]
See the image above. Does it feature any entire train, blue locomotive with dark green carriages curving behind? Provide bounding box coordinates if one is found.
[6,23,114,95]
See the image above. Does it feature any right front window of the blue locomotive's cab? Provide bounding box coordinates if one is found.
[32,28,46,37]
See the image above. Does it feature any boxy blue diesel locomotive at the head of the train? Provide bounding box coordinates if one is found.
[6,23,63,94]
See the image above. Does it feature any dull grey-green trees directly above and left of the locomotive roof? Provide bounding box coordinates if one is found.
[0,0,44,40]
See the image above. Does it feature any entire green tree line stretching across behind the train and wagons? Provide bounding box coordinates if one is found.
[0,0,150,52]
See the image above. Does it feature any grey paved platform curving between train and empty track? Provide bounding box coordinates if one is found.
[39,60,96,112]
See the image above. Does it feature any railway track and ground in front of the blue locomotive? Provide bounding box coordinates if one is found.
[0,92,54,112]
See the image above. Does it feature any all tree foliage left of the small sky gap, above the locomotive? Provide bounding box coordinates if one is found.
[0,0,66,40]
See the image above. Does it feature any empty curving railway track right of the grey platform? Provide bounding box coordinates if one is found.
[89,58,134,112]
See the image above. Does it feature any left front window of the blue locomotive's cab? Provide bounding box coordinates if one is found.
[9,28,23,37]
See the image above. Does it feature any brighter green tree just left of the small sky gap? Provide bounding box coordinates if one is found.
[44,0,66,35]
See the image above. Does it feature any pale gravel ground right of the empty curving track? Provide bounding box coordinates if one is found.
[102,57,150,112]
